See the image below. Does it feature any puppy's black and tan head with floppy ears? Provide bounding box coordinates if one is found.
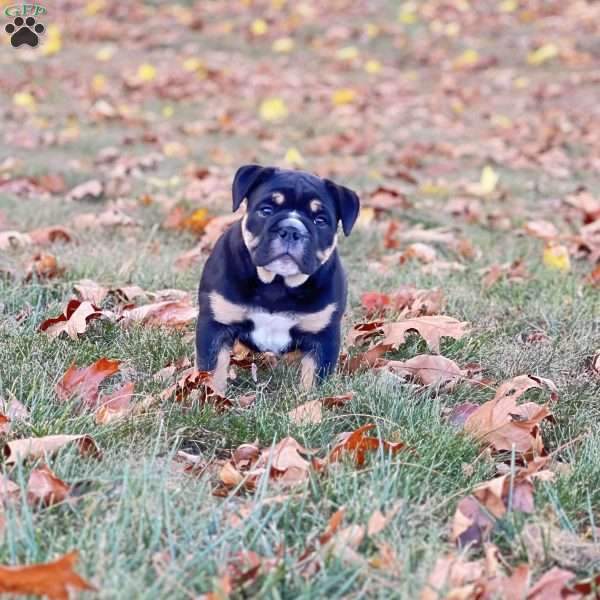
[233,165,359,282]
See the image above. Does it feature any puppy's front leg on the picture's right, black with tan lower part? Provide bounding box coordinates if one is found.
[300,323,341,390]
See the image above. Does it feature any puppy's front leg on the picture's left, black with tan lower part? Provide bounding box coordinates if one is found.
[196,318,233,395]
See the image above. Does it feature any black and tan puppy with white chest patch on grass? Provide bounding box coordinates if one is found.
[196,165,359,393]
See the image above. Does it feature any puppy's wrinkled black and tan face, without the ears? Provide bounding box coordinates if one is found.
[242,171,339,277]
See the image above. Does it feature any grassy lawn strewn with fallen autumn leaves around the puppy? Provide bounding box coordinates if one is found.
[0,0,600,600]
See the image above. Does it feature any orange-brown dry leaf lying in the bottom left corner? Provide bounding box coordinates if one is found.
[0,550,96,600]
